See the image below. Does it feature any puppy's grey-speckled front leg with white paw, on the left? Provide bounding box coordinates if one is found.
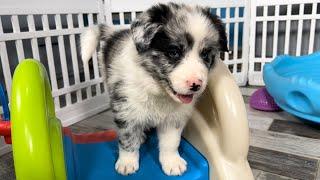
[115,119,145,175]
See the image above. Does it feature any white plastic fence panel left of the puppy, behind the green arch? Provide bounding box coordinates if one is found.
[0,0,108,125]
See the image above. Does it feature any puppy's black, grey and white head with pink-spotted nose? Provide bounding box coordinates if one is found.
[131,3,228,104]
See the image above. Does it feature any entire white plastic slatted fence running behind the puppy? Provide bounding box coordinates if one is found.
[0,0,320,125]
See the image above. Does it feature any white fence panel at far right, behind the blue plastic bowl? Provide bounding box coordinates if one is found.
[248,0,320,85]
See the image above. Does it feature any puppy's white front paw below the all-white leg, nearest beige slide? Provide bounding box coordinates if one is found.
[160,153,187,176]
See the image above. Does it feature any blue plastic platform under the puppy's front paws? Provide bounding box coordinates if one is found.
[64,133,209,180]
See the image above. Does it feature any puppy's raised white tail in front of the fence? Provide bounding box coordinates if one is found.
[80,24,112,63]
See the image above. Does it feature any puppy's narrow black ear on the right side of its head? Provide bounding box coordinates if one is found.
[202,8,228,52]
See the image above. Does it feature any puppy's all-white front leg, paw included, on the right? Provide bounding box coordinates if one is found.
[157,125,187,176]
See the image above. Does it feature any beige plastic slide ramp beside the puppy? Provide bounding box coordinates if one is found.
[183,60,254,180]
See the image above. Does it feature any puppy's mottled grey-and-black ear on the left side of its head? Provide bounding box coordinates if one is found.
[131,4,173,53]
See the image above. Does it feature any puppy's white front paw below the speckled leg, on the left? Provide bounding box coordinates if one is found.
[115,155,139,175]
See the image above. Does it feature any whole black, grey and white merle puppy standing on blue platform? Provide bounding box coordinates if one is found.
[81,3,227,175]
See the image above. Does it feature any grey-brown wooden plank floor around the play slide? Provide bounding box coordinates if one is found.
[0,96,320,180]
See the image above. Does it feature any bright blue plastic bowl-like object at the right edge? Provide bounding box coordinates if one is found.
[263,52,320,123]
